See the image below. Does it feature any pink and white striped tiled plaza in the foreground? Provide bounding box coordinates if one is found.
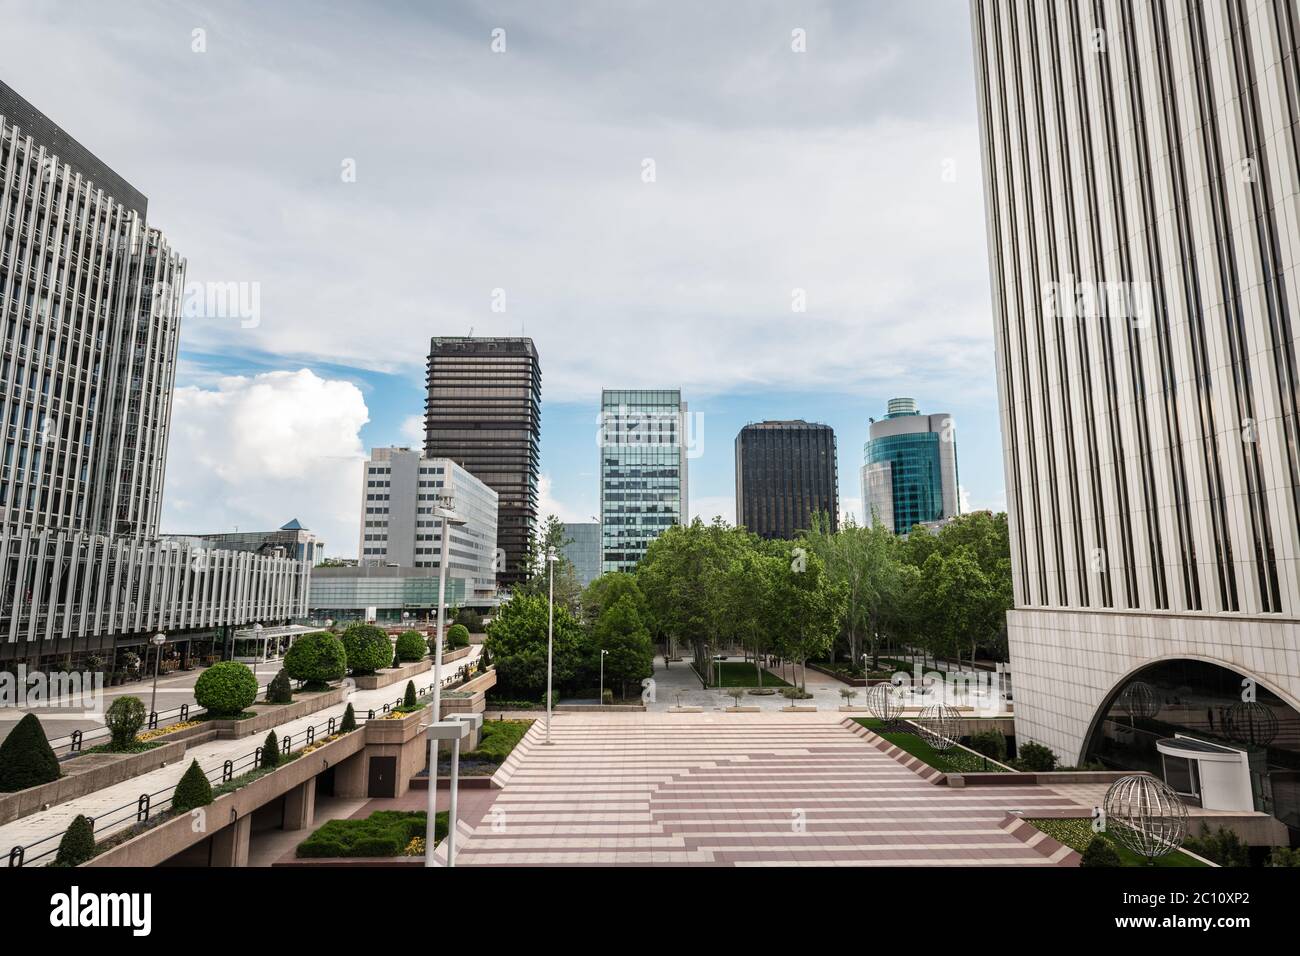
[458,713,1078,866]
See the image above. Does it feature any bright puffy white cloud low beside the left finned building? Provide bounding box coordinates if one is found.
[163,368,369,555]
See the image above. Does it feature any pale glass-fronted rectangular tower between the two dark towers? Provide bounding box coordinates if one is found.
[597,389,692,572]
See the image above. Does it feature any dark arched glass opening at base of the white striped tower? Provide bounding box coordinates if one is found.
[1084,658,1300,835]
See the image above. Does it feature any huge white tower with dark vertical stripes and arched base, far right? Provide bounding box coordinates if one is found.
[971,0,1300,832]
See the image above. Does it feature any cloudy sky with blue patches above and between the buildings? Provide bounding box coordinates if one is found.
[0,0,1005,557]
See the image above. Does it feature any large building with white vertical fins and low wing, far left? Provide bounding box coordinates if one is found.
[0,83,311,666]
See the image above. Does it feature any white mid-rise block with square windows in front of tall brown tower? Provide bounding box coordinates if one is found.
[356,447,499,602]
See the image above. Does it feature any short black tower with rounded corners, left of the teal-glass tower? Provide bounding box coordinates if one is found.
[736,420,840,540]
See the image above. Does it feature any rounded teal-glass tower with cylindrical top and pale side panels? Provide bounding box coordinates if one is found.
[862,398,961,535]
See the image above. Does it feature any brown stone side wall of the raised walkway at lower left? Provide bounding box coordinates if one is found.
[82,731,365,866]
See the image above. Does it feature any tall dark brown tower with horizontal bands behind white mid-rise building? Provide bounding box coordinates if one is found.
[424,337,542,588]
